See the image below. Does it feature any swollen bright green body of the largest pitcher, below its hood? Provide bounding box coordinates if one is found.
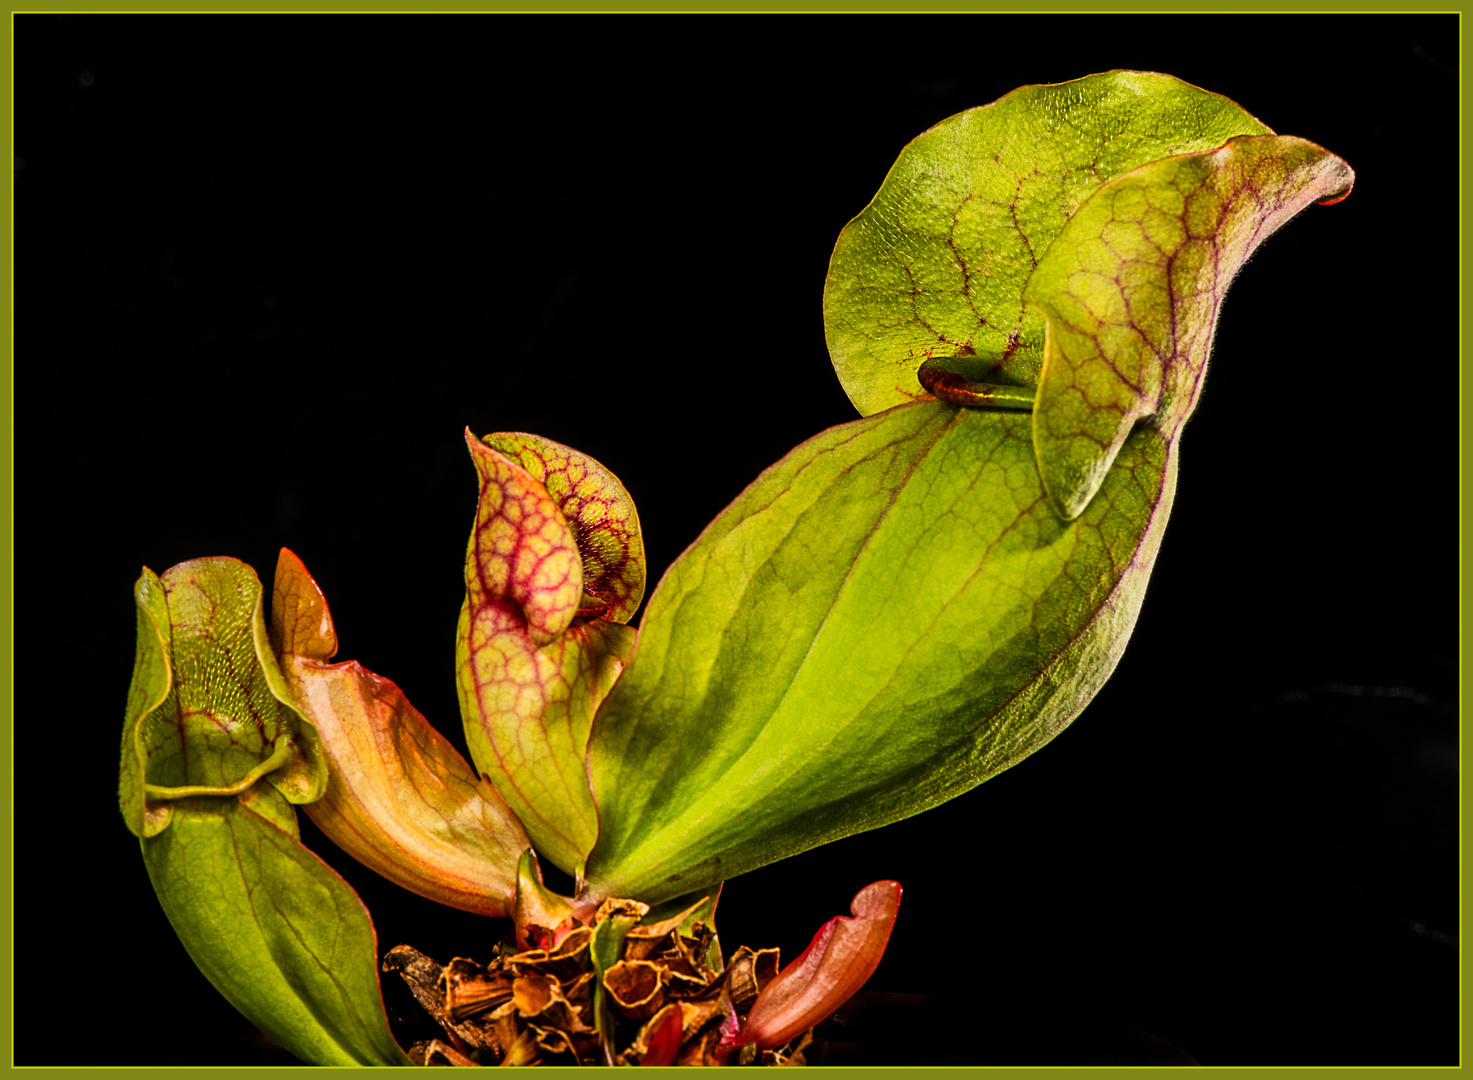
[588,401,1175,903]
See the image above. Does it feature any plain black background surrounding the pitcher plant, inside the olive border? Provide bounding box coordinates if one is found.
[15,16,1458,1065]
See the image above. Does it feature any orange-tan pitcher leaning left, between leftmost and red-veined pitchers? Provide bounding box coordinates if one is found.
[271,548,530,918]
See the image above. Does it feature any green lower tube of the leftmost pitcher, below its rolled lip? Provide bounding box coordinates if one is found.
[140,787,409,1065]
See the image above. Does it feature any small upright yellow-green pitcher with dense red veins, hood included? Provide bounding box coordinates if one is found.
[455,432,644,875]
